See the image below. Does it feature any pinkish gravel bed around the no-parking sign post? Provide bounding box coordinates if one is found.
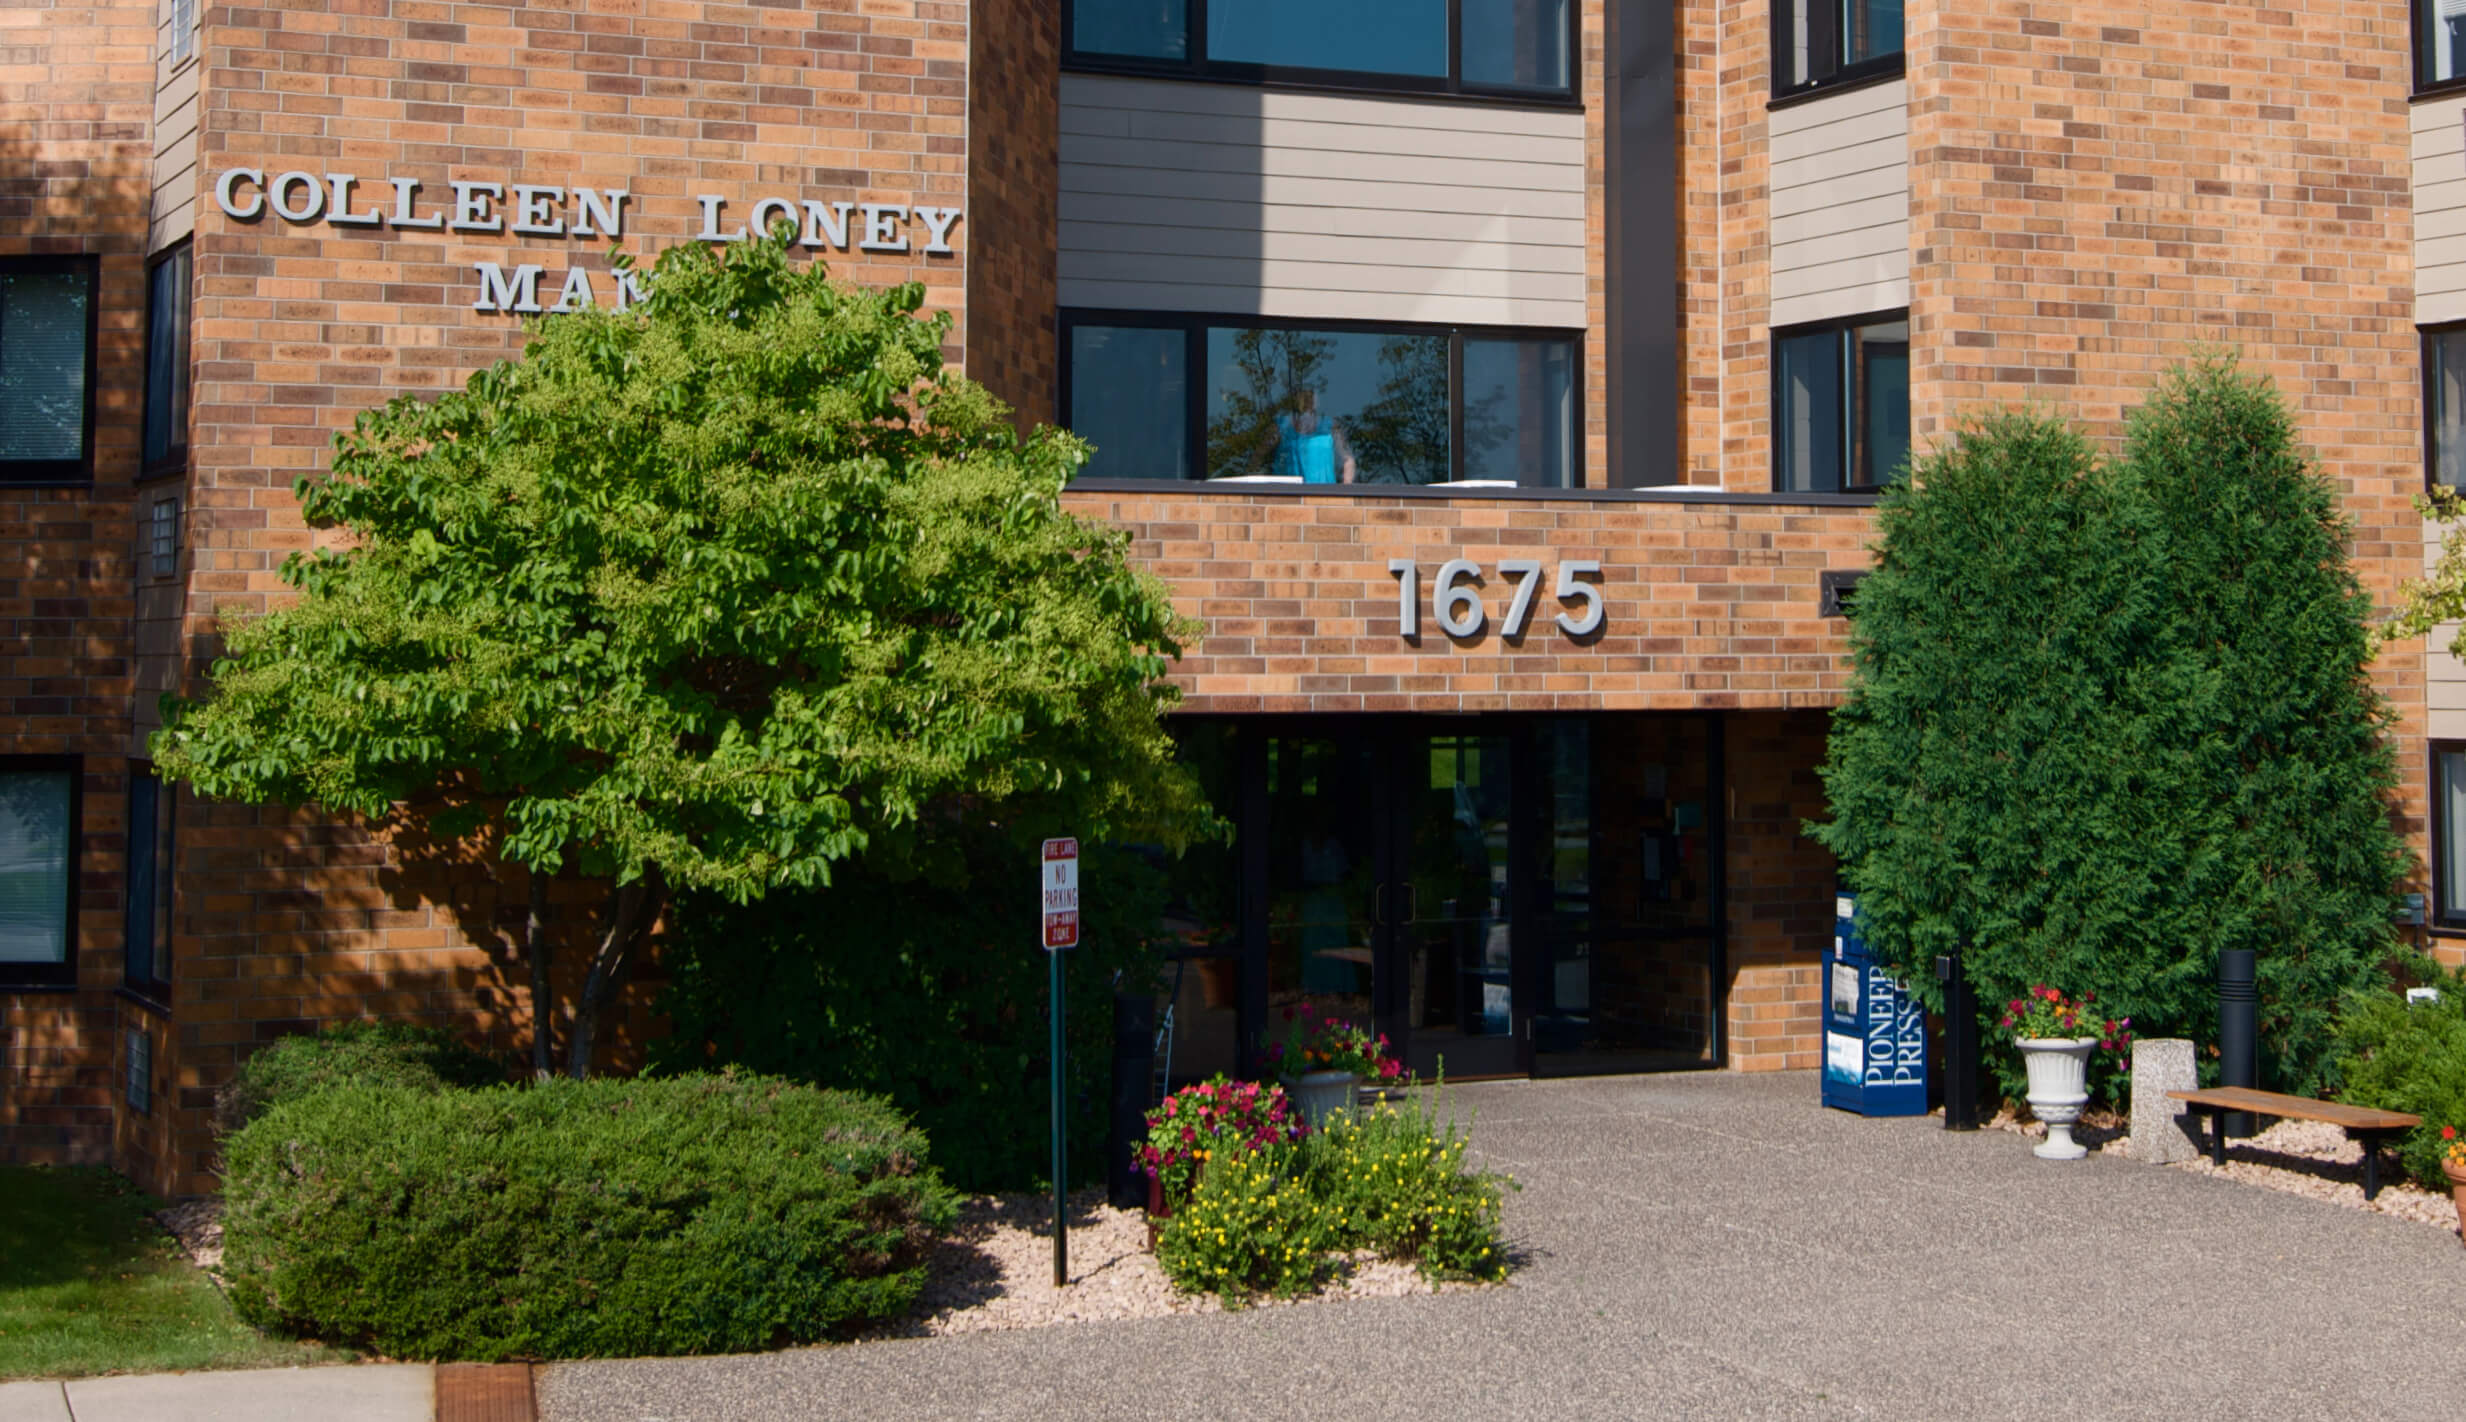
[861,1190,1482,1341]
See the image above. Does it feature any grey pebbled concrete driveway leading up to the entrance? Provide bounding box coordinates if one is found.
[538,1075,2466,1422]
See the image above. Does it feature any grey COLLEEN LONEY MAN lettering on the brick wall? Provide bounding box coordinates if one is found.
[215,168,962,311]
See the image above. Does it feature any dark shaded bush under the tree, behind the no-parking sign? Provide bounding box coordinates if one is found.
[651,828,1164,1190]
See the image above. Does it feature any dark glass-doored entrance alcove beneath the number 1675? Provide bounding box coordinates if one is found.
[1164,712,1724,1079]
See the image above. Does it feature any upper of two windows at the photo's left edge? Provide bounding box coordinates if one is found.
[0,256,96,483]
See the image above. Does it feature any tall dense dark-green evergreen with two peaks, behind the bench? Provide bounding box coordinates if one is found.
[1810,360,2409,1092]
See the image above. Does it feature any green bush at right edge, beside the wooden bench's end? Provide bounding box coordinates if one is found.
[2338,973,2466,1190]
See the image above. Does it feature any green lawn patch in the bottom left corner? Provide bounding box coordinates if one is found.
[0,1166,348,1378]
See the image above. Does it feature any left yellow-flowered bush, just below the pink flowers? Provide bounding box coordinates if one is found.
[1157,1146,1339,1299]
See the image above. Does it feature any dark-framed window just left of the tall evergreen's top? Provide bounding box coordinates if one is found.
[1773,315,1909,493]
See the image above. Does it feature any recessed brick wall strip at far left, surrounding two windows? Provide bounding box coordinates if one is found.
[0,2,155,1163]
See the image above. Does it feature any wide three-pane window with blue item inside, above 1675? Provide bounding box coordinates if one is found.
[1063,311,1583,488]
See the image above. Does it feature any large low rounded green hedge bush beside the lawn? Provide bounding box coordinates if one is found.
[222,1075,957,1360]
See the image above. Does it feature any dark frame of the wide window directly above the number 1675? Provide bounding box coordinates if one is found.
[1053,306,1586,487]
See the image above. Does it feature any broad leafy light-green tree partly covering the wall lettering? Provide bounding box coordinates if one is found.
[153,237,1208,1077]
